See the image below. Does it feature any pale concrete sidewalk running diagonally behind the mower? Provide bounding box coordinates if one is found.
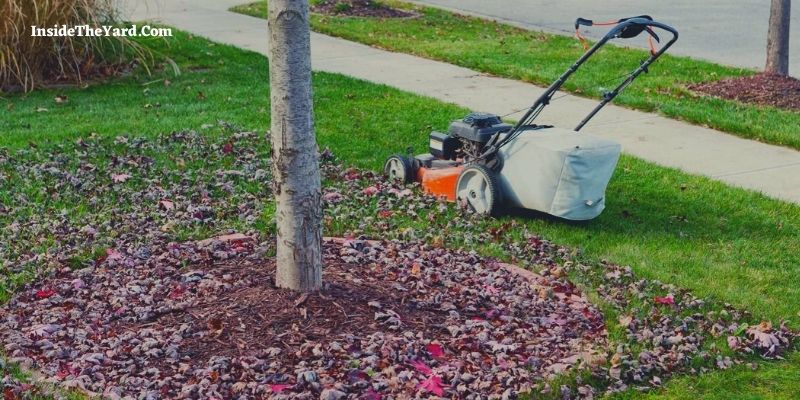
[127,0,800,203]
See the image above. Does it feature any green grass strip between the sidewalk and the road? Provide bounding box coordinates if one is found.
[233,1,800,149]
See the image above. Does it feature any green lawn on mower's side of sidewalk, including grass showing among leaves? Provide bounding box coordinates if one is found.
[0,28,800,398]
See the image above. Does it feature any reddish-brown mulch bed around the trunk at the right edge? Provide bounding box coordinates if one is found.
[689,73,800,111]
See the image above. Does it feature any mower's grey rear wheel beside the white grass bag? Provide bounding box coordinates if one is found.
[456,164,501,215]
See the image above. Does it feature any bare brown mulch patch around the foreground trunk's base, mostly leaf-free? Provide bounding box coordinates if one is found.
[156,253,447,362]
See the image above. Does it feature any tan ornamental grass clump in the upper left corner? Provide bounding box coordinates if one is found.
[0,0,152,92]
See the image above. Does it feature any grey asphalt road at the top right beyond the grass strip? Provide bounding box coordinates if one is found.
[417,0,800,76]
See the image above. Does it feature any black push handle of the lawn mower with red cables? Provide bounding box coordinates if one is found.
[480,15,678,159]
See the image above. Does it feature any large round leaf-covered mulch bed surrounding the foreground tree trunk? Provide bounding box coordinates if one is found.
[0,236,606,399]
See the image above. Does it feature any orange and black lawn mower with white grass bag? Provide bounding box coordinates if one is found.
[384,15,678,220]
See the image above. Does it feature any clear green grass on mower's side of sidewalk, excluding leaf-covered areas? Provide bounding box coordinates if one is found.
[0,26,800,398]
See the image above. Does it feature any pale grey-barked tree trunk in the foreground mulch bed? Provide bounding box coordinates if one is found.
[269,0,322,291]
